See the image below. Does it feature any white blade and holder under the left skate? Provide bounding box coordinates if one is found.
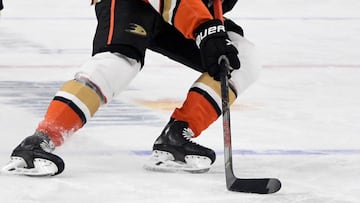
[1,157,58,176]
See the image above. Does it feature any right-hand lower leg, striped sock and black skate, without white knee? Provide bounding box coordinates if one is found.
[146,73,236,172]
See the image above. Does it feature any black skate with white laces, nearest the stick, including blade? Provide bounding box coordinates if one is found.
[145,119,216,173]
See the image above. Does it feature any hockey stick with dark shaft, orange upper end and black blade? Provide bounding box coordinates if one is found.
[213,0,281,194]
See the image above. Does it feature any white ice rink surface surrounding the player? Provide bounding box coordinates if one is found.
[0,0,360,203]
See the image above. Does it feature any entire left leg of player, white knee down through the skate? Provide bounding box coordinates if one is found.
[2,53,141,176]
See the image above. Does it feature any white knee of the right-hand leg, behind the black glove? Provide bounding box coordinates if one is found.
[228,31,261,95]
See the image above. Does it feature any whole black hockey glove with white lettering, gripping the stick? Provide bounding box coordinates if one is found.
[195,20,240,80]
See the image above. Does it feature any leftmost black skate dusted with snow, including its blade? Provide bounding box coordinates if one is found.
[1,132,65,176]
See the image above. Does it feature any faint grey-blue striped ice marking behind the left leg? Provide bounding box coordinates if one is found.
[0,81,163,127]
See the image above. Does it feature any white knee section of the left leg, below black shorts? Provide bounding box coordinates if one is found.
[75,52,141,103]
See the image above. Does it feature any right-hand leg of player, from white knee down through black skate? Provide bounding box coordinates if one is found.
[147,35,261,171]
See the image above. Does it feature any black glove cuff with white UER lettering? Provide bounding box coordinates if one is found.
[195,19,227,48]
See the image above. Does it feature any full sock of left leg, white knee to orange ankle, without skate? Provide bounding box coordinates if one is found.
[37,52,141,146]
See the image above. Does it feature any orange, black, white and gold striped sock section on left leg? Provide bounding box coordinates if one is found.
[36,80,101,146]
